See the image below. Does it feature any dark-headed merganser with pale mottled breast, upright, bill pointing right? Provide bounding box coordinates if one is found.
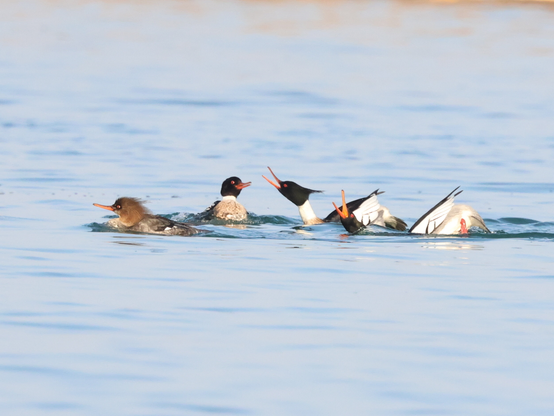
[200,176,251,221]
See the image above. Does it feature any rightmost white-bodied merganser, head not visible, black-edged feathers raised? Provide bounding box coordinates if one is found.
[410,186,491,235]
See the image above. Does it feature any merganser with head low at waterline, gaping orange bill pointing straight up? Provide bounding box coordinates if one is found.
[333,189,386,234]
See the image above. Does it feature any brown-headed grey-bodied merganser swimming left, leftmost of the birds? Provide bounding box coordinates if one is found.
[93,197,201,235]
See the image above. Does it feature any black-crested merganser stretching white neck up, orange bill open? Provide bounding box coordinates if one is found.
[262,166,407,231]
